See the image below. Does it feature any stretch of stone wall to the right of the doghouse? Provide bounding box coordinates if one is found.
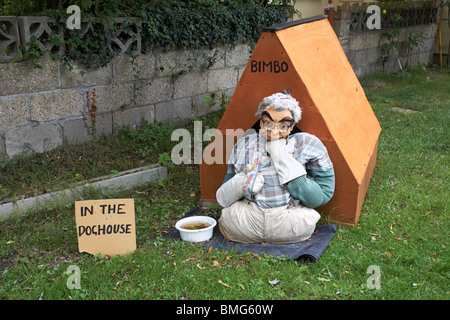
[333,1,440,76]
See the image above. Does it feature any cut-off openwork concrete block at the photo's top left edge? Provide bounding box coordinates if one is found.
[0,17,20,63]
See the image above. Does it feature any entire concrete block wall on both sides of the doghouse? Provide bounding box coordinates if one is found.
[0,1,437,161]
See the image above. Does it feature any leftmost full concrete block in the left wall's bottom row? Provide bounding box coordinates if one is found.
[5,123,63,157]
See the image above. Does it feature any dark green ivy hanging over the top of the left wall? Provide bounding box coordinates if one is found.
[5,0,295,70]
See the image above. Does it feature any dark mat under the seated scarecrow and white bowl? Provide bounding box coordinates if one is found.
[163,207,337,262]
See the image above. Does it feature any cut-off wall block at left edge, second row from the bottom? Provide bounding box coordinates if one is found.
[0,96,29,131]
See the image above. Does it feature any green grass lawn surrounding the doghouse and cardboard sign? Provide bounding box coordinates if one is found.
[0,69,450,300]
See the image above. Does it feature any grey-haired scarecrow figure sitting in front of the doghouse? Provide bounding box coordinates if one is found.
[216,91,335,244]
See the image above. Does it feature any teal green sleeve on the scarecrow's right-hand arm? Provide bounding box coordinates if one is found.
[287,169,335,208]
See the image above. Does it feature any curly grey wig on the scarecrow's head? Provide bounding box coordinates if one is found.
[256,90,302,122]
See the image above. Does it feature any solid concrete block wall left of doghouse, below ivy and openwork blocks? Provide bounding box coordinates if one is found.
[0,44,251,160]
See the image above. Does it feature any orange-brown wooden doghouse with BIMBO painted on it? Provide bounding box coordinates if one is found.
[200,15,381,226]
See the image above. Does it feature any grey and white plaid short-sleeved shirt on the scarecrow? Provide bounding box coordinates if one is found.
[227,132,333,208]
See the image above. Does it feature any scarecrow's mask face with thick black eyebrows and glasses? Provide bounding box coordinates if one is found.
[260,107,294,140]
